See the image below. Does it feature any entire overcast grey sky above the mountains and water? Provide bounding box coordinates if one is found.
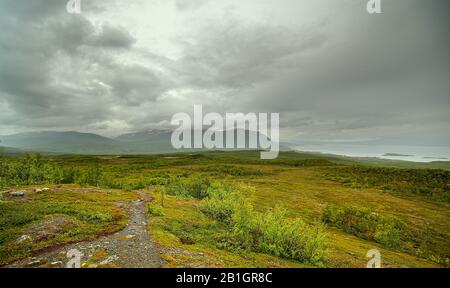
[0,0,450,146]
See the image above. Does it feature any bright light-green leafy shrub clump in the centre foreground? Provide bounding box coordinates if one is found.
[201,183,327,265]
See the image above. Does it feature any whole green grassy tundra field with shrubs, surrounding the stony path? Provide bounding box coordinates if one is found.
[0,151,450,267]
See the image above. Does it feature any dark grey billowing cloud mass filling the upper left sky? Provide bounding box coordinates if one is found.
[0,1,167,130]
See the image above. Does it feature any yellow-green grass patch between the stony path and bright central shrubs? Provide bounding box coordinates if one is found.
[149,192,307,268]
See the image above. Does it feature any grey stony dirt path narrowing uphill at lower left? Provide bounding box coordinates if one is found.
[7,191,163,268]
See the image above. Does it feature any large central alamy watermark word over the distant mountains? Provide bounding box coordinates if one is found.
[171,105,280,160]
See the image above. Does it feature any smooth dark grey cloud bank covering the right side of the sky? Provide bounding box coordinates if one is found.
[198,1,450,144]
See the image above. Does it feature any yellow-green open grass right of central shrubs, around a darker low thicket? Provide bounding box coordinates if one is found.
[248,168,450,267]
